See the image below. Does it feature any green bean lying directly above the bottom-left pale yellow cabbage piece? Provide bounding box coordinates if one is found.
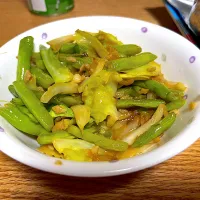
[37,131,74,145]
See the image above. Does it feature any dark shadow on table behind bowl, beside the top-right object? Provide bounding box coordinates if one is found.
[145,7,180,33]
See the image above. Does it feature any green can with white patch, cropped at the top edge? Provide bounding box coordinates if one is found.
[28,0,74,16]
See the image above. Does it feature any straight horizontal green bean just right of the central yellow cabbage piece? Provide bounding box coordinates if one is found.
[117,99,165,109]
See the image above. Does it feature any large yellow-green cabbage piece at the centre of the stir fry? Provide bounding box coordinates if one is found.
[79,70,121,123]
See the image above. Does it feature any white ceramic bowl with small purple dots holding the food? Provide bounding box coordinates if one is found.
[0,16,200,177]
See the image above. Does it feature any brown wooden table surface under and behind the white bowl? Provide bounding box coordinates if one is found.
[0,0,200,200]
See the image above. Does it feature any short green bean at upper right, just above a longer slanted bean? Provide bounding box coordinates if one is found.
[114,44,142,56]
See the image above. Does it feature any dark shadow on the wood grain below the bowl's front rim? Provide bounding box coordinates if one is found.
[35,168,148,200]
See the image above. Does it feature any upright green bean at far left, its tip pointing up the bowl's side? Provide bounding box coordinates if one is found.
[17,36,33,80]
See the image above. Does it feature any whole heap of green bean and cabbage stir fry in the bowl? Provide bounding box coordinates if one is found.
[0,30,186,161]
